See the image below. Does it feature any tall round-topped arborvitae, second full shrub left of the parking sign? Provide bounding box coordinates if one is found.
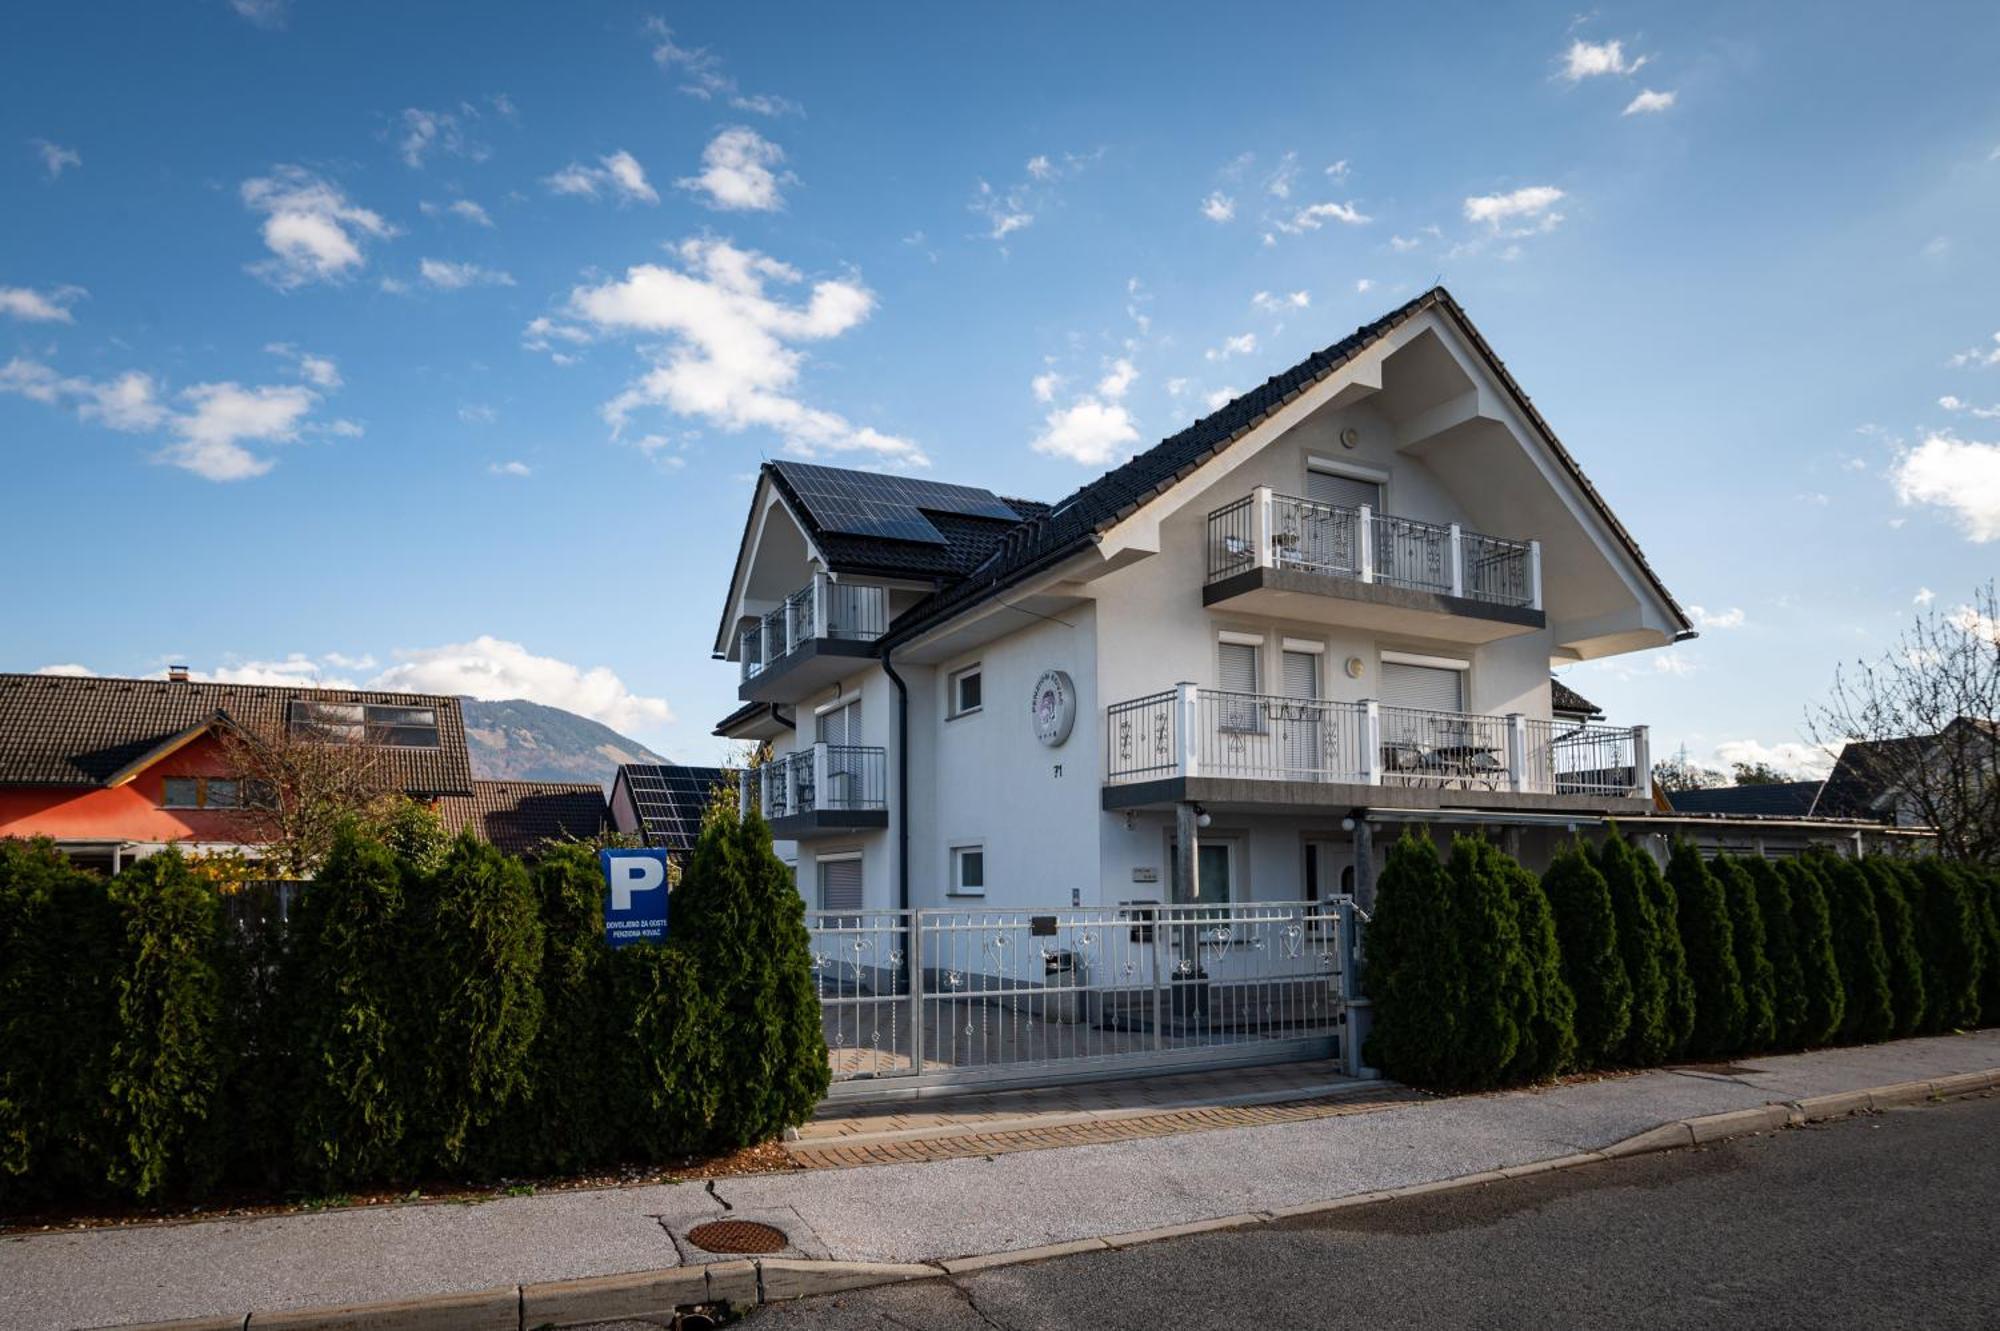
[282,823,414,1191]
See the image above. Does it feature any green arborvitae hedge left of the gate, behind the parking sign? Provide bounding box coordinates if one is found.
[0,791,828,1209]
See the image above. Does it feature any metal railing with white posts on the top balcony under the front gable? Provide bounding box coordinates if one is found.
[1208,486,1542,610]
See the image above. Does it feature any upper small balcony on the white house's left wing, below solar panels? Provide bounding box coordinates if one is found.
[736,574,888,703]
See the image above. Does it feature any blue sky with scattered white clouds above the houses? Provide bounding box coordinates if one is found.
[0,0,2000,771]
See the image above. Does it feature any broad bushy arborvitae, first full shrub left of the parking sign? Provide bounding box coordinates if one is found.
[410,831,542,1173]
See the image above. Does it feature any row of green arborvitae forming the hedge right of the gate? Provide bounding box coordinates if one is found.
[1362,829,2000,1089]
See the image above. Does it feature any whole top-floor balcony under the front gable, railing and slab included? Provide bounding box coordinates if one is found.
[1202,486,1546,644]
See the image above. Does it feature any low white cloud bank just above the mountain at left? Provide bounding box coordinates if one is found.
[368,636,674,729]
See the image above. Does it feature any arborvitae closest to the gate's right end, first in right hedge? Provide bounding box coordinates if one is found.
[1360,829,1464,1087]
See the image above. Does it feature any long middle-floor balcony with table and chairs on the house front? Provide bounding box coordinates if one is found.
[1104,683,1650,811]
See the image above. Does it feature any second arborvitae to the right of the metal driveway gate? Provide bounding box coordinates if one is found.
[1444,835,1534,1089]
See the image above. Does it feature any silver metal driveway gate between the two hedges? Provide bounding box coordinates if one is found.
[806,897,1356,1099]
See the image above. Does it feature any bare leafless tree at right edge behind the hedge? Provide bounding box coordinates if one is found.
[1808,582,2000,863]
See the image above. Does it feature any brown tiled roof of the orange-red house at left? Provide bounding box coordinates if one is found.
[0,673,472,795]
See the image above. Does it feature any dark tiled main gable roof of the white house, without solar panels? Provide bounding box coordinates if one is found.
[884,286,1694,644]
